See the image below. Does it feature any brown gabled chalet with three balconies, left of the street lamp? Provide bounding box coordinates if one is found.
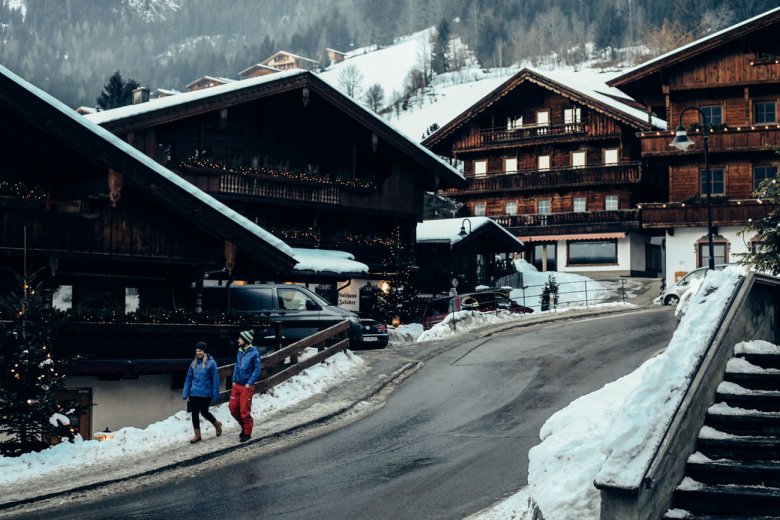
[423,69,666,275]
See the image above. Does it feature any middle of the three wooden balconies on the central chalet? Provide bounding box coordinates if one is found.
[446,162,642,196]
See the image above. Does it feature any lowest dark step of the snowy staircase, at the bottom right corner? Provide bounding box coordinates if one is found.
[672,479,780,518]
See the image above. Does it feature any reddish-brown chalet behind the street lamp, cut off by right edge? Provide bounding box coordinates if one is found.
[609,8,780,283]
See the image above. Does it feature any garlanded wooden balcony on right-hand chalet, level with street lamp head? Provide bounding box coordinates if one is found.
[640,124,780,157]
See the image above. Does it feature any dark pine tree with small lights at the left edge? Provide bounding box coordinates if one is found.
[0,272,75,455]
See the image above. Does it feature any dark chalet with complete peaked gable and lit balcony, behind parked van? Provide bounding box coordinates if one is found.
[89,71,465,298]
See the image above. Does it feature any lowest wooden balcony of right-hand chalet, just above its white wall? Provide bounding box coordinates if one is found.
[641,199,773,229]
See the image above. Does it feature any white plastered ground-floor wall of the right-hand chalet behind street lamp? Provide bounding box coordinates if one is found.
[665,226,750,287]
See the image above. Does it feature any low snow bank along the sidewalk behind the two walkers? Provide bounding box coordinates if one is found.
[0,349,364,485]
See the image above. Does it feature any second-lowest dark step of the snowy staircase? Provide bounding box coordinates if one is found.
[685,460,780,487]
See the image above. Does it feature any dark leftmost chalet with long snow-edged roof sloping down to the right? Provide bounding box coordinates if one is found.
[0,66,296,439]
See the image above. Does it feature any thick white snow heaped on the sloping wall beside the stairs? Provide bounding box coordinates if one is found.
[528,266,746,520]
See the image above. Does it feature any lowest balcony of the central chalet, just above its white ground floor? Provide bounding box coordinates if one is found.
[491,209,639,235]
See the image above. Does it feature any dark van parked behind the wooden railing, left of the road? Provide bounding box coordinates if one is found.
[193,283,389,348]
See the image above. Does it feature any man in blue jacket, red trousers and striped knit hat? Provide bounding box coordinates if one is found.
[229,330,260,442]
